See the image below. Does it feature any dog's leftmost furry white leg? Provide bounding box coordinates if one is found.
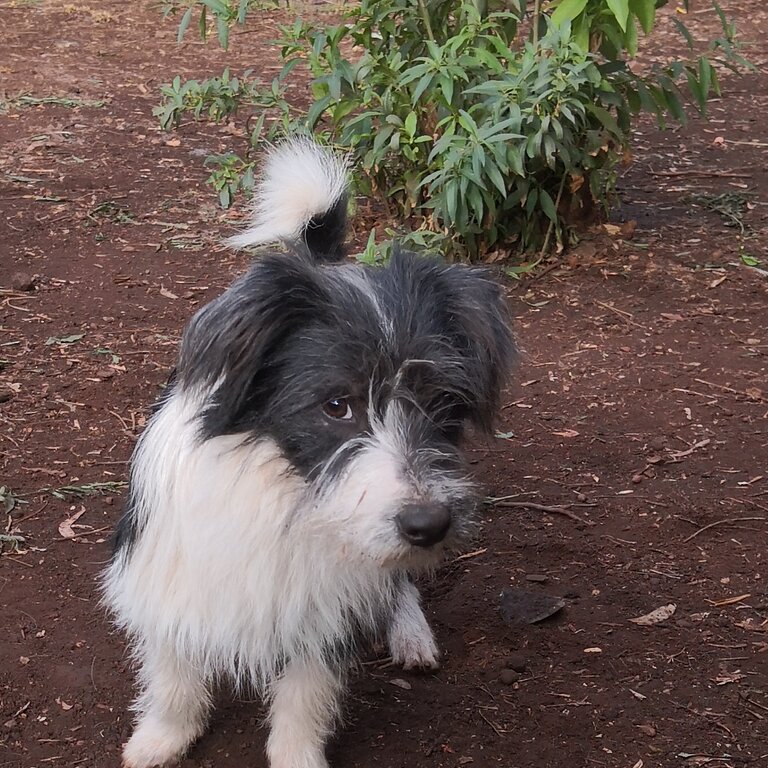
[123,646,211,768]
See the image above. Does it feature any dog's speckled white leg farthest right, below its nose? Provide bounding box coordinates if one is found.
[387,578,440,669]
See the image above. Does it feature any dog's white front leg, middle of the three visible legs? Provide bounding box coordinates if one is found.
[267,660,343,768]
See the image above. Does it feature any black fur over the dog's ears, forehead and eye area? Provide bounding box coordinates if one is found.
[178,253,514,478]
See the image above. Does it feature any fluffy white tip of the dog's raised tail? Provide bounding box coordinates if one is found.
[227,137,349,248]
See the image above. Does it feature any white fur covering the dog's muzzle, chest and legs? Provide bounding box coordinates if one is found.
[104,390,452,768]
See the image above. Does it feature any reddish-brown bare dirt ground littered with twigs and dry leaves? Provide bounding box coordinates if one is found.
[0,0,768,768]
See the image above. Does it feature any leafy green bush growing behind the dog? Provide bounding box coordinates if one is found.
[158,0,744,259]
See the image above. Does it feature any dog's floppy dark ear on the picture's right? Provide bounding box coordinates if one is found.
[440,265,517,432]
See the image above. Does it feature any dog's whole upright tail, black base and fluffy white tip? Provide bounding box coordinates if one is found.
[227,137,348,261]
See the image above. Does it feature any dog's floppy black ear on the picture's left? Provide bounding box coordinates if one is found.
[178,254,329,437]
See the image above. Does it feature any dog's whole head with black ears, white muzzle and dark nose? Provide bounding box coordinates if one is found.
[179,249,514,567]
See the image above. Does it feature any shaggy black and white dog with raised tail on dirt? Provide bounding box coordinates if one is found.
[104,139,514,768]
